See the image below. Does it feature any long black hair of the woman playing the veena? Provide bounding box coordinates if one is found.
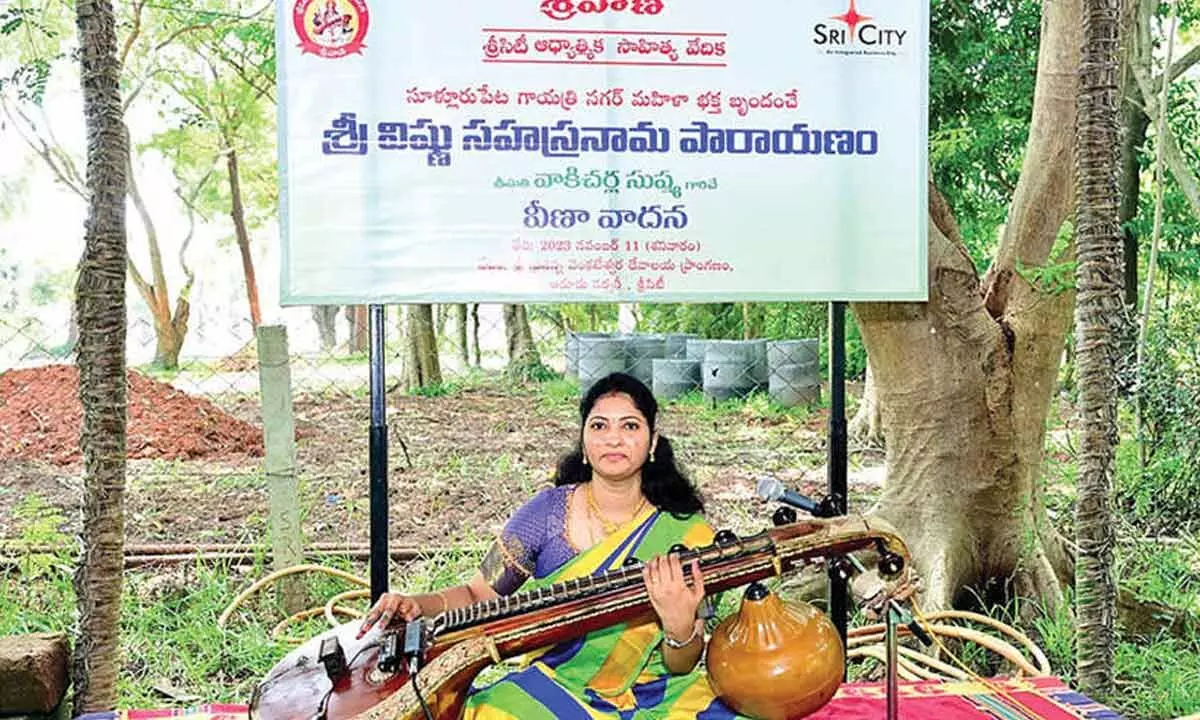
[554,372,704,515]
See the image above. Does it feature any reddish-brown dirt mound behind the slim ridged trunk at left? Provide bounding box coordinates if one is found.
[0,365,263,464]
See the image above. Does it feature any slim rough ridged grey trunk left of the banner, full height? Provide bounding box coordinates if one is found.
[72,0,128,715]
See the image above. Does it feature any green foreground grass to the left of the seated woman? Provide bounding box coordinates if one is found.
[0,541,481,708]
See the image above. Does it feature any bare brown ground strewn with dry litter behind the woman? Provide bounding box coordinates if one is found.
[0,388,881,547]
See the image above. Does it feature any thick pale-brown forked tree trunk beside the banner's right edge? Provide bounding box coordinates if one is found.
[853,0,1082,607]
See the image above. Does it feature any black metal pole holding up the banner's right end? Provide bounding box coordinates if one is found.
[826,297,850,667]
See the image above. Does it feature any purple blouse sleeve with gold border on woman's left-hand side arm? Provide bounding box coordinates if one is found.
[480,487,566,595]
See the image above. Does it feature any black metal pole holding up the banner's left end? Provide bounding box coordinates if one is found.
[368,305,389,602]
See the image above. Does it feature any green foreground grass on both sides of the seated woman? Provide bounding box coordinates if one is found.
[0,520,1200,720]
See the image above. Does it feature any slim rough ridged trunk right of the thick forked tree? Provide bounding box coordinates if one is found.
[1075,0,1122,700]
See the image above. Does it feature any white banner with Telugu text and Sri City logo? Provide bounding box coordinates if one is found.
[278,0,929,305]
